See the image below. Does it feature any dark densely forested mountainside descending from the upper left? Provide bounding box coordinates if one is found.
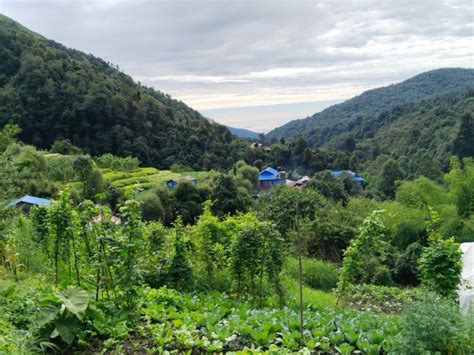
[0,15,233,169]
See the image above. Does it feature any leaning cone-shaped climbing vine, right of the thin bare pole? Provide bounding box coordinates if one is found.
[340,211,392,289]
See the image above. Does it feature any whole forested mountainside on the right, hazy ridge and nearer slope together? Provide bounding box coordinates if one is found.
[267,69,474,189]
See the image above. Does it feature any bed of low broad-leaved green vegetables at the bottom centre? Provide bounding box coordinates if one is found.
[143,288,399,353]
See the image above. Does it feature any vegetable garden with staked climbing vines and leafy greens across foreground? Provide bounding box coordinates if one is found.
[0,192,473,354]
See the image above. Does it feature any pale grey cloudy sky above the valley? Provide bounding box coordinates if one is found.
[0,0,474,131]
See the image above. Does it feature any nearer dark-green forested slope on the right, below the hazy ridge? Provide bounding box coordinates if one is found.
[352,90,474,179]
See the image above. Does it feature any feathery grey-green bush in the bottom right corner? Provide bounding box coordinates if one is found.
[394,292,474,354]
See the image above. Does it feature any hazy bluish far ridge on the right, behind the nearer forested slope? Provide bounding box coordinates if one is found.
[267,68,474,147]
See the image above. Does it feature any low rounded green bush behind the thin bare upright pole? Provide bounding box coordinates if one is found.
[284,258,339,290]
